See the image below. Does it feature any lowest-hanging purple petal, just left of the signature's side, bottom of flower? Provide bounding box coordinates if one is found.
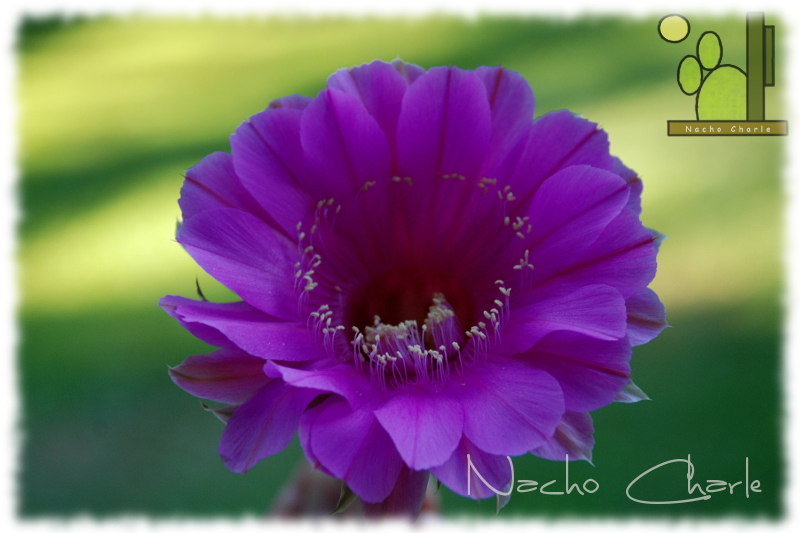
[309,400,403,503]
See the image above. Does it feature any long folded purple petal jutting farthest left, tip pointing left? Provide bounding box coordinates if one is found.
[160,296,325,364]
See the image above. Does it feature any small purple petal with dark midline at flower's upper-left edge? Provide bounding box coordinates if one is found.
[178,152,265,221]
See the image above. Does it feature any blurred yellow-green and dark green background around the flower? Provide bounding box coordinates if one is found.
[17,13,786,518]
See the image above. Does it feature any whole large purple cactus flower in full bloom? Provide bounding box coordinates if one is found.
[161,61,665,514]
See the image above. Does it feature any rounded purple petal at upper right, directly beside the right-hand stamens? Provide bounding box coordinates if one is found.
[528,166,629,279]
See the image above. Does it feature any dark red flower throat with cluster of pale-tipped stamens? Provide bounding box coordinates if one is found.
[347,270,510,386]
